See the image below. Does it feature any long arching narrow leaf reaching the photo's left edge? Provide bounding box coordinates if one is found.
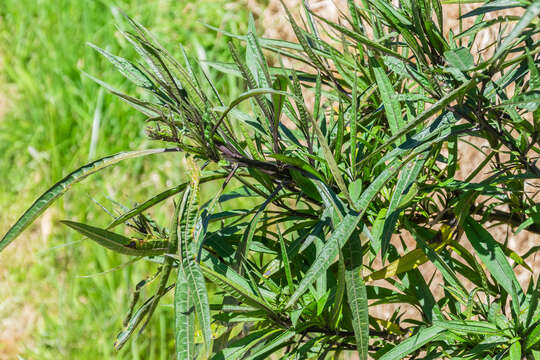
[0,148,178,251]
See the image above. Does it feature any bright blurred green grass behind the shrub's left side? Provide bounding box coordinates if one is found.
[0,0,253,360]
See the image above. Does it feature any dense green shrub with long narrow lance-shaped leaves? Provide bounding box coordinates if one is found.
[0,0,540,360]
